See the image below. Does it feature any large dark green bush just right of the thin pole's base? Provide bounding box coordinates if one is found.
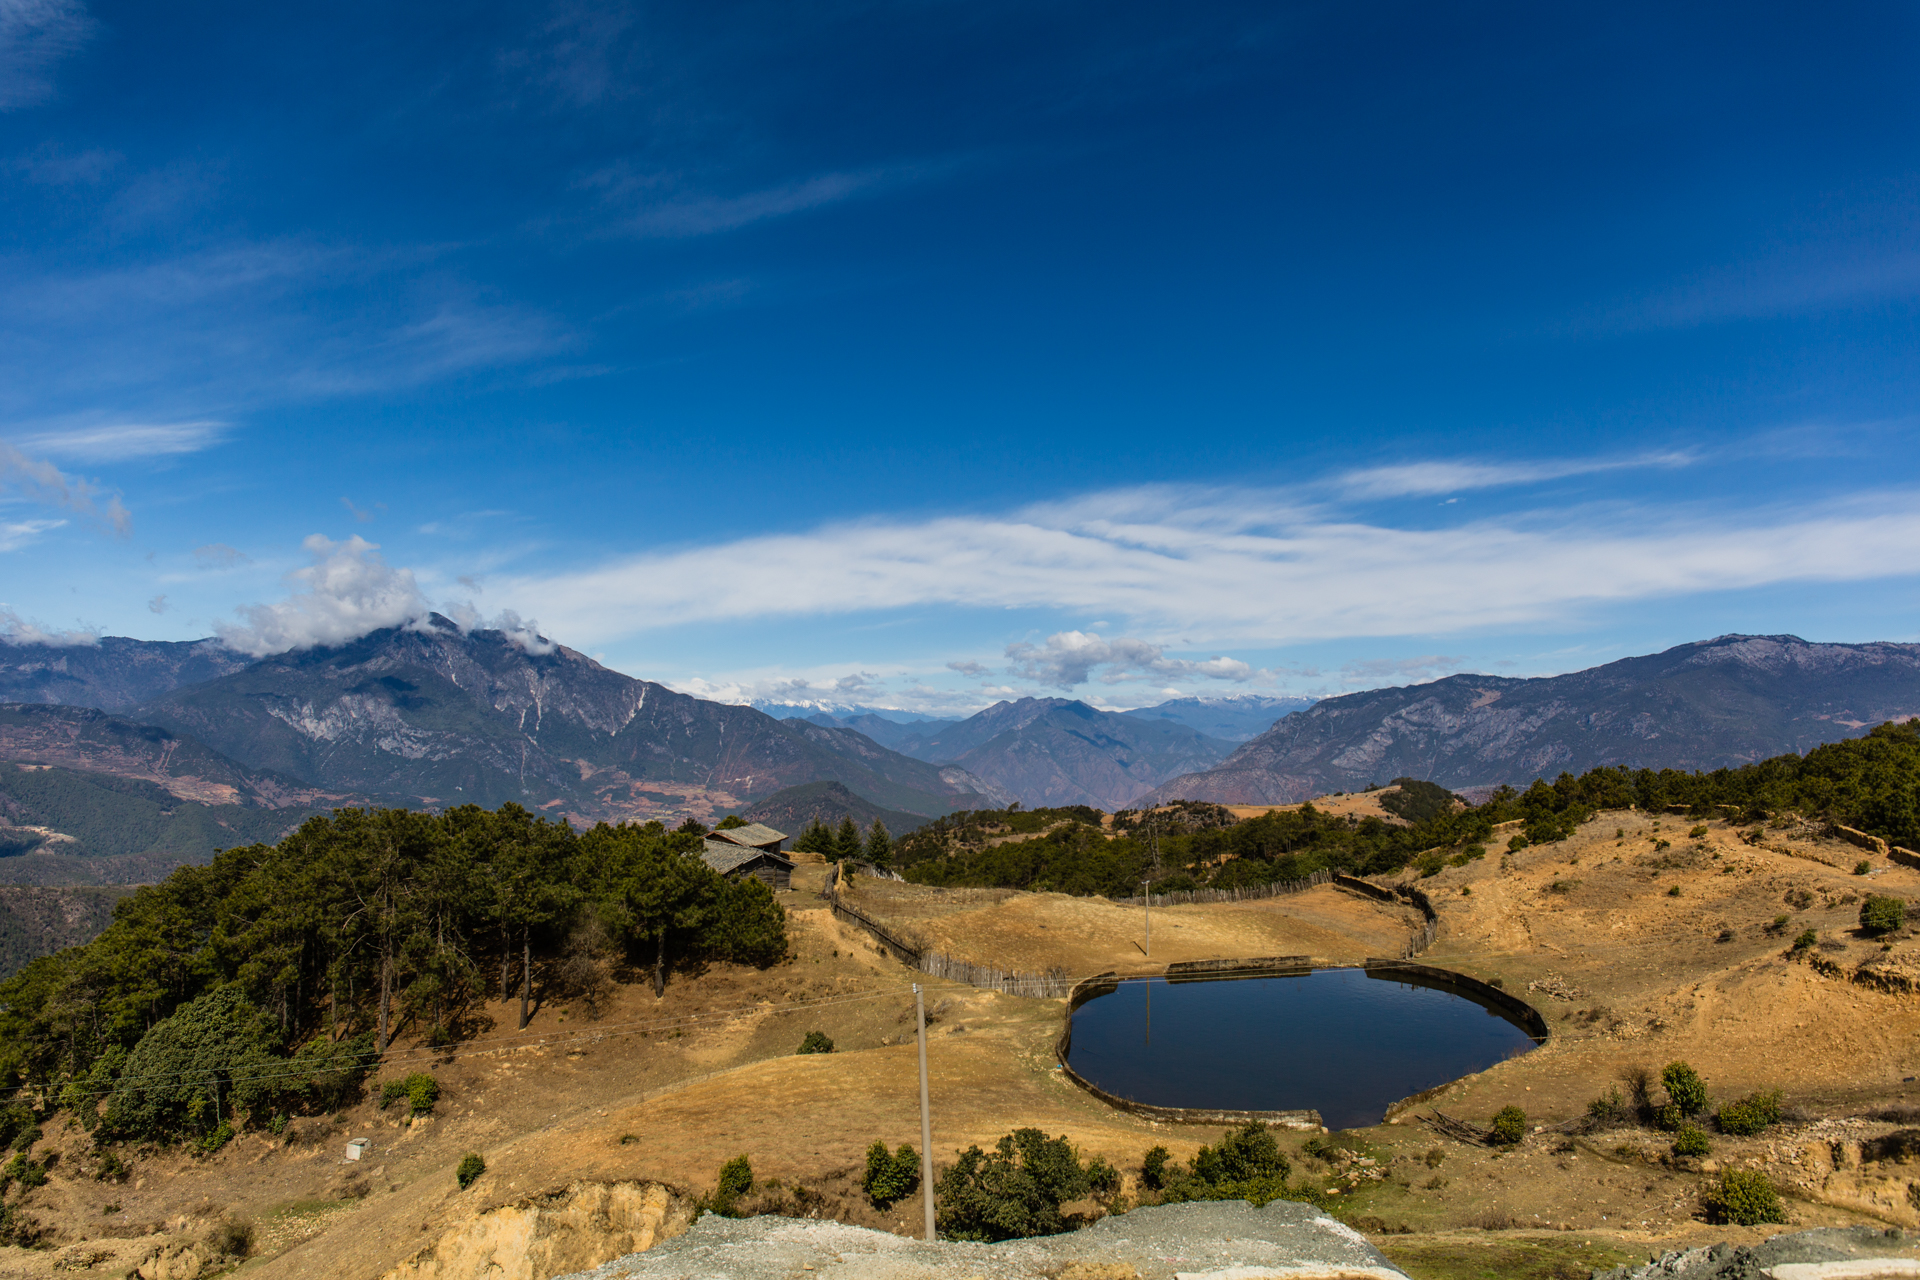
[933,1128,1092,1240]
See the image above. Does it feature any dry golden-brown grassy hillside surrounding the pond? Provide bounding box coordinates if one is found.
[0,814,1920,1280]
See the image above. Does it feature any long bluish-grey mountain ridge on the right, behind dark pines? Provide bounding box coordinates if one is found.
[1148,635,1920,804]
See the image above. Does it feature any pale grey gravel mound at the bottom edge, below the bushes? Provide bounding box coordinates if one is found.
[566,1201,1407,1280]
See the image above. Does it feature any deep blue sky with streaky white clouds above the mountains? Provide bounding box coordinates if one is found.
[0,0,1920,710]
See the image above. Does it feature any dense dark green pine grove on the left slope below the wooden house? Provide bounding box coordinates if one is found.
[0,804,787,1140]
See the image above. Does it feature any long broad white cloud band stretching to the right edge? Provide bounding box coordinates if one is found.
[490,479,1920,647]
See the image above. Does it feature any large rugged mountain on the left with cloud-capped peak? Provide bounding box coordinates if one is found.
[0,614,1012,821]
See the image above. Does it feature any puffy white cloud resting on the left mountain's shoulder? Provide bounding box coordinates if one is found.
[213,533,428,658]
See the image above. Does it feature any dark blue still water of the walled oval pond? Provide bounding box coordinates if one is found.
[1068,969,1534,1128]
